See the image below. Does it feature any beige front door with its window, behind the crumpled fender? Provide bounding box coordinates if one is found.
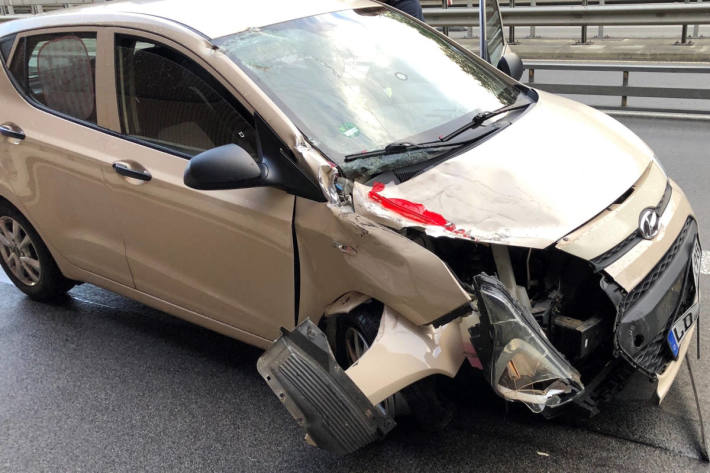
[107,34,295,340]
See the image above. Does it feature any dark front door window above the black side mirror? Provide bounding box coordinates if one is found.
[116,35,257,158]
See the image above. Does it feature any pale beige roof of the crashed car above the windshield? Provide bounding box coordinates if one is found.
[0,0,377,39]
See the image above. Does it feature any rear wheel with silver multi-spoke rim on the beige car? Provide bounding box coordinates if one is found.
[0,202,74,302]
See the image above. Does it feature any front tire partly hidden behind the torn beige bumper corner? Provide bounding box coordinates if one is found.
[335,301,454,432]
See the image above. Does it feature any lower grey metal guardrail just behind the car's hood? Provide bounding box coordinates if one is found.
[525,61,710,120]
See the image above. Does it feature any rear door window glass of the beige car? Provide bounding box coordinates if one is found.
[10,33,96,123]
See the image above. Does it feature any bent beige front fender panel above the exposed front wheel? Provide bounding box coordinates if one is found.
[296,198,470,325]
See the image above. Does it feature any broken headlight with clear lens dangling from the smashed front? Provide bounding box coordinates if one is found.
[469,274,584,413]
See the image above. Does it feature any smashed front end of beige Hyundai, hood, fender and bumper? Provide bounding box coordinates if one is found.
[259,95,699,454]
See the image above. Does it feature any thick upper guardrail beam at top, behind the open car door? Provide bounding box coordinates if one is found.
[424,3,710,26]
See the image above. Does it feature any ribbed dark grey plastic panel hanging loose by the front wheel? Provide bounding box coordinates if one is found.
[256,320,396,455]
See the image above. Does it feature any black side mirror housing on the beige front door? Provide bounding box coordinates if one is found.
[184,144,265,190]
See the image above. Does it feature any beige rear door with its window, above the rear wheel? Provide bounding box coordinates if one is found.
[0,28,132,286]
